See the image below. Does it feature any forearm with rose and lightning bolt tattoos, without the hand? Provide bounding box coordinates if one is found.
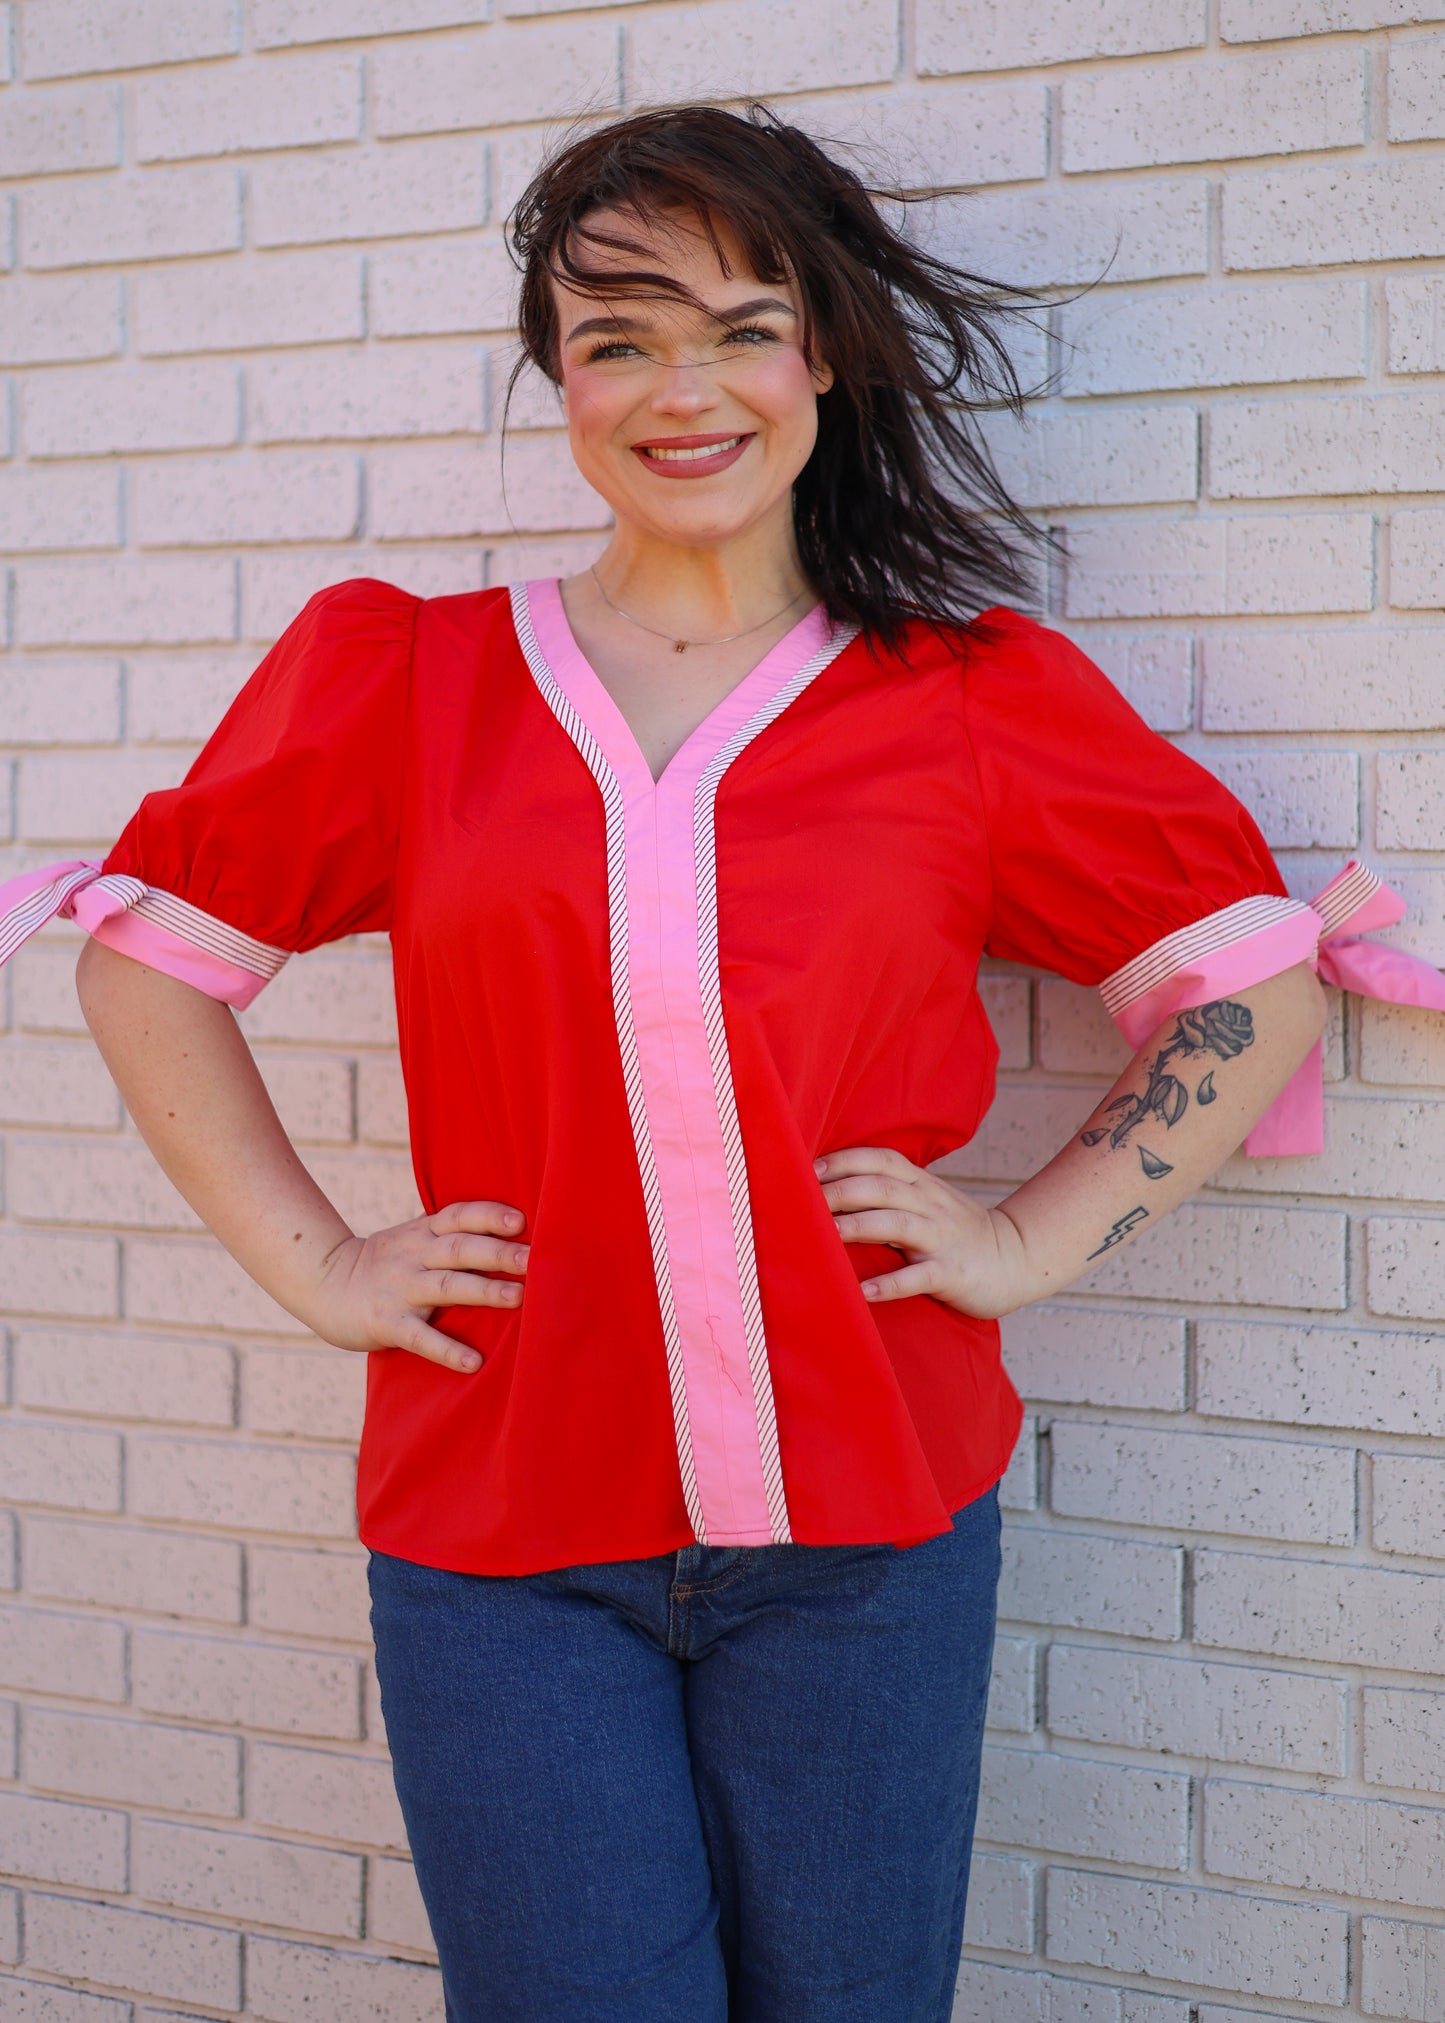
[998,963,1324,1305]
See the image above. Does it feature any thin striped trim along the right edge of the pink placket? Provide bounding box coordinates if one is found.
[692,625,858,1546]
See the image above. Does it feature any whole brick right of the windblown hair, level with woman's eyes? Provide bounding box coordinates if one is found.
[1060,281,1368,394]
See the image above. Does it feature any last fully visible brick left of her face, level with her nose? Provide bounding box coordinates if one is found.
[249,344,486,443]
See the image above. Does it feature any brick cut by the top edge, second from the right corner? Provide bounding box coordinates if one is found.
[917,0,1204,77]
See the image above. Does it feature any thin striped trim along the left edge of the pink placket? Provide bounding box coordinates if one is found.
[510,583,708,1546]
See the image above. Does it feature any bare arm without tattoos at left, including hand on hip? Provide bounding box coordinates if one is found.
[77,941,526,1370]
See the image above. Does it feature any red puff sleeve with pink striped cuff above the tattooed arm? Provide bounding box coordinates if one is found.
[963,613,1320,1044]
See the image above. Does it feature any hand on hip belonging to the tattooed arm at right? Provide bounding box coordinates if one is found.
[814,1145,1038,1321]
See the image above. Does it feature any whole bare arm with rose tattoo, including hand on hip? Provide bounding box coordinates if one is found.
[818,963,1324,1317]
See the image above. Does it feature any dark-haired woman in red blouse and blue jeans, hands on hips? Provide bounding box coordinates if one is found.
[11,107,1322,2023]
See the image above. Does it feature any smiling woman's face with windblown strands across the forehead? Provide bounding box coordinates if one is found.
[557,212,832,546]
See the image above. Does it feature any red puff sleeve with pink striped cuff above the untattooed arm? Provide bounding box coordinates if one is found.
[87,579,417,1005]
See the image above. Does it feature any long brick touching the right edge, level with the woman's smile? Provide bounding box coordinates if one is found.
[1208,392,1445,498]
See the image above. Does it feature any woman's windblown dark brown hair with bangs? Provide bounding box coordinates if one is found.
[508,105,1040,641]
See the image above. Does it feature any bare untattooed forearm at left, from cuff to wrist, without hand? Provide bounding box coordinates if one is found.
[77,941,352,1325]
